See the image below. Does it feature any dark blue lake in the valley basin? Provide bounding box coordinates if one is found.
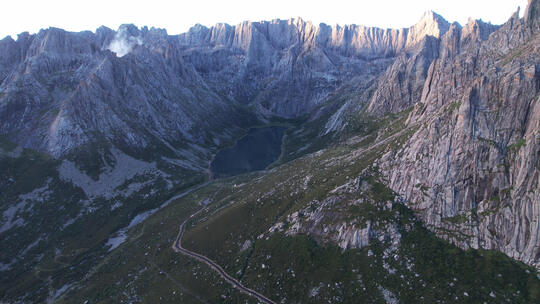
[210,127,286,177]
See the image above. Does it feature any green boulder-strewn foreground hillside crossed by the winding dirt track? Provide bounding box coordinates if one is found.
[60,108,540,303]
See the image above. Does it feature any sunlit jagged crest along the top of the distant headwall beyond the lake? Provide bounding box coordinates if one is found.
[179,11,450,58]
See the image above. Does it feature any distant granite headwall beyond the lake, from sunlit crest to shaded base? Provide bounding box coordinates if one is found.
[179,12,449,118]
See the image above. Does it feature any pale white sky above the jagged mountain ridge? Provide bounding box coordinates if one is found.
[0,0,527,38]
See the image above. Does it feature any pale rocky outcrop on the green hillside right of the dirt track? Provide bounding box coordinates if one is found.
[268,173,408,250]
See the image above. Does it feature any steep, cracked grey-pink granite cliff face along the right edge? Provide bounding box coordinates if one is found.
[368,1,540,268]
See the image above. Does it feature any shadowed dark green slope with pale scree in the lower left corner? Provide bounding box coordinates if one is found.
[0,144,204,303]
